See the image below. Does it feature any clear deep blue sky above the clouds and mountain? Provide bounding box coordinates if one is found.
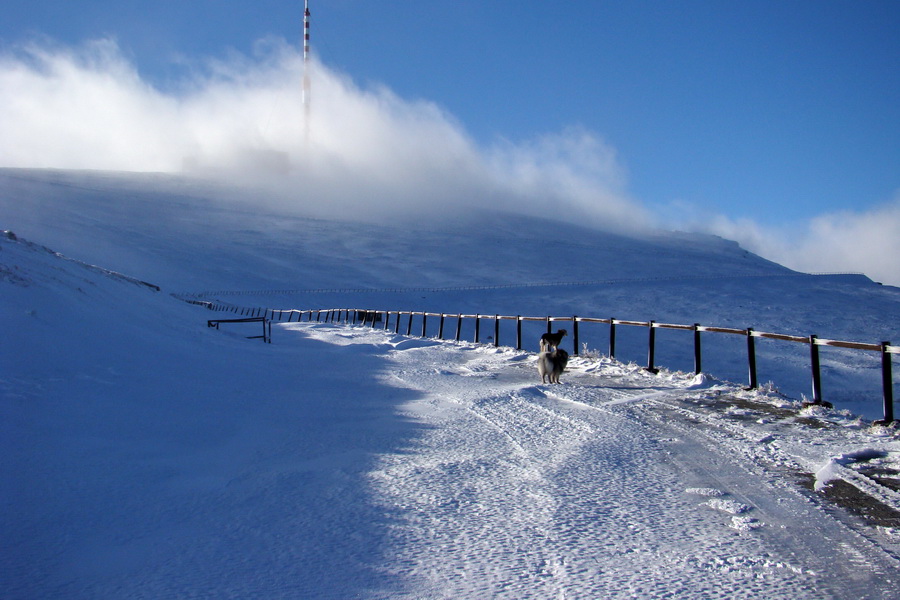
[0,0,900,282]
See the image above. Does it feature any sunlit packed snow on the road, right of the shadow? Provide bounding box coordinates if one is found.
[291,325,898,599]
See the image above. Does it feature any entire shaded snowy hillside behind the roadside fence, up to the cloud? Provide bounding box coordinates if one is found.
[0,169,900,418]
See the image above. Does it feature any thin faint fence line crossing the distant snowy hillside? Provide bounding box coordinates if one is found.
[185,272,866,300]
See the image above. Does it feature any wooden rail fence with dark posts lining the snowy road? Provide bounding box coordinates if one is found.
[182,298,900,423]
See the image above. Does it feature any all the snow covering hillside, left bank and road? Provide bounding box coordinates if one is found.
[0,170,900,599]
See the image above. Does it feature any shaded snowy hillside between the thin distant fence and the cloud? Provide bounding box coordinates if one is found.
[0,169,789,292]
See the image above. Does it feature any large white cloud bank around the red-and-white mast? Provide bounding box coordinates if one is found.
[0,40,648,228]
